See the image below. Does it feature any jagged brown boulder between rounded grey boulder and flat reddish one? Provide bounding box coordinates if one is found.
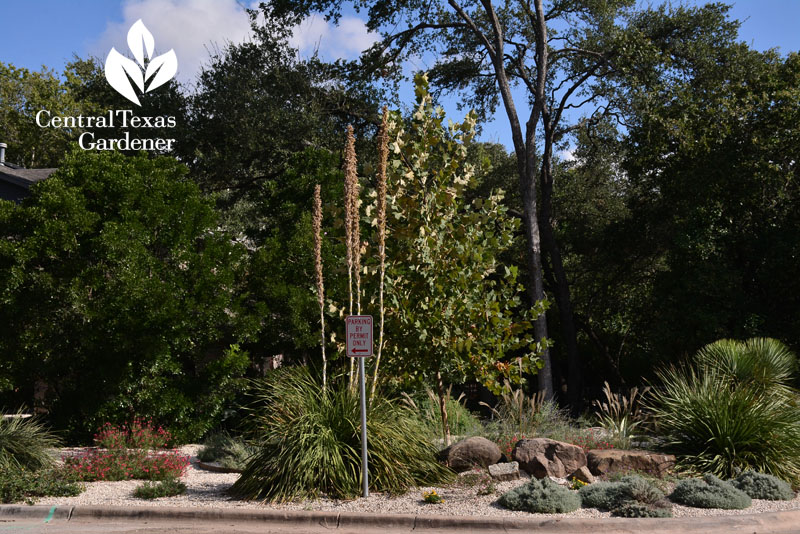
[512,438,586,478]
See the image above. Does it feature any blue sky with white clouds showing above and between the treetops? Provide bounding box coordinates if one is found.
[0,0,800,151]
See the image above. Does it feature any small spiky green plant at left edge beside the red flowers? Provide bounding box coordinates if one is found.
[0,413,61,470]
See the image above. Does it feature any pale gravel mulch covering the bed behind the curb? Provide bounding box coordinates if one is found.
[37,445,800,518]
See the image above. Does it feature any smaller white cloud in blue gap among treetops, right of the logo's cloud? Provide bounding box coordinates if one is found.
[289,15,380,60]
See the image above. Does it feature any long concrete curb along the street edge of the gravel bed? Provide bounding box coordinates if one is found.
[0,505,800,534]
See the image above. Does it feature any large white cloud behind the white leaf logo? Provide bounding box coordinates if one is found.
[90,0,255,86]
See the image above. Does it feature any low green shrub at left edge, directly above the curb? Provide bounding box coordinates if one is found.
[0,462,85,504]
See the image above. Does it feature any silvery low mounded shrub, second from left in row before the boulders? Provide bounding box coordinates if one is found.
[579,475,671,517]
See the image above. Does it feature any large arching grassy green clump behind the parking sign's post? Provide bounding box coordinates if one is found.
[231,367,455,502]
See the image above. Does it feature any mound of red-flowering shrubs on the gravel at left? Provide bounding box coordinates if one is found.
[64,418,189,482]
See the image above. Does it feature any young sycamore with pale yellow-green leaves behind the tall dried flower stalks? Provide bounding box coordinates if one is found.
[384,75,547,442]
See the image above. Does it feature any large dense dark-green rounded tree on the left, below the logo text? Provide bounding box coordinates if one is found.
[0,150,258,440]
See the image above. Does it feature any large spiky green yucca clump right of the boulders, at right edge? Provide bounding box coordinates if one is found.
[647,340,800,485]
